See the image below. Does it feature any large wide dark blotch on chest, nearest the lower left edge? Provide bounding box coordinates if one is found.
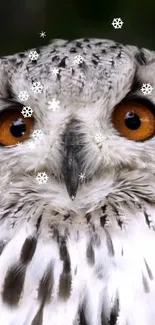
[2,263,26,306]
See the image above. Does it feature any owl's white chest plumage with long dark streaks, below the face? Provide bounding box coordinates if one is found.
[0,201,155,325]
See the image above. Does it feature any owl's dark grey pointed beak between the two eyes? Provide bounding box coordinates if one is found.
[63,146,79,200]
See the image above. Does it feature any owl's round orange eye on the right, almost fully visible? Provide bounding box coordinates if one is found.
[112,101,155,141]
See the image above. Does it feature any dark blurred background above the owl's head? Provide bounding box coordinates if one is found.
[0,0,155,55]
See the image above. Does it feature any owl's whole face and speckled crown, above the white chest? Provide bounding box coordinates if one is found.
[0,39,155,211]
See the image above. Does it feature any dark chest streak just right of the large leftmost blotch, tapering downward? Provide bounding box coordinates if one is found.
[38,263,54,305]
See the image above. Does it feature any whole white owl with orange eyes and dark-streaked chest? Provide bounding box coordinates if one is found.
[0,39,155,325]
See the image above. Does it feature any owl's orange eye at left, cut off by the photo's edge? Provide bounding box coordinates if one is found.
[0,108,34,146]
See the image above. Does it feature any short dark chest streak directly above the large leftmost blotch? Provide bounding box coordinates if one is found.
[20,237,37,264]
